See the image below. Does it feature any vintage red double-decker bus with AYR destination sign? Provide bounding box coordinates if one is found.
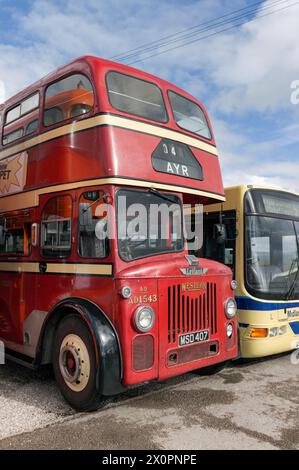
[0,57,237,410]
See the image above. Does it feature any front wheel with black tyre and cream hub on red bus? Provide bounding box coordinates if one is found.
[53,314,104,411]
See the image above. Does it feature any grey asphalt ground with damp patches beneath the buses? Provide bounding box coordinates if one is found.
[0,354,299,450]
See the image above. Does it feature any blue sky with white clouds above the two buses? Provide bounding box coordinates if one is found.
[0,0,299,192]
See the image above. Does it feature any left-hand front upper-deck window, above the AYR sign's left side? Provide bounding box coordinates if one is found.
[107,72,168,122]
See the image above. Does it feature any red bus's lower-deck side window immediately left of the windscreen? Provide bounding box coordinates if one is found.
[78,191,108,258]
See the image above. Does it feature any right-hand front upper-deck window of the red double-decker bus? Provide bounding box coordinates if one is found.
[168,91,212,139]
